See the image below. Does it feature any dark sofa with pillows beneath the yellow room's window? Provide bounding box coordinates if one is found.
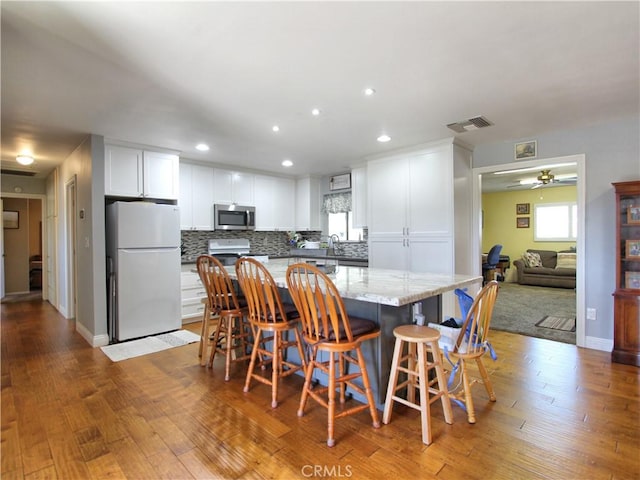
[513,249,576,288]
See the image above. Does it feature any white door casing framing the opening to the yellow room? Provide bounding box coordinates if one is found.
[473,154,586,347]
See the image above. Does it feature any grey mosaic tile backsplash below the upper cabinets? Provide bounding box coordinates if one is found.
[181,230,369,258]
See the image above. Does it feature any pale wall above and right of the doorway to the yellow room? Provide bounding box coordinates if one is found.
[473,116,640,340]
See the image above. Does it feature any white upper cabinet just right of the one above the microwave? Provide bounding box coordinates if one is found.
[254,175,295,231]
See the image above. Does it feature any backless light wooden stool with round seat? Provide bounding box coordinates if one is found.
[382,325,453,445]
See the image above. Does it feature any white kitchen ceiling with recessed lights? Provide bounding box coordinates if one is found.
[1,1,640,186]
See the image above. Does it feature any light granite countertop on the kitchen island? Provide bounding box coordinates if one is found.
[227,259,482,307]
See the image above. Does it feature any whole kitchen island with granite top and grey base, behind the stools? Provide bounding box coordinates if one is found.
[226,259,482,408]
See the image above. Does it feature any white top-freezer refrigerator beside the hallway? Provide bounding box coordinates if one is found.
[106,202,182,342]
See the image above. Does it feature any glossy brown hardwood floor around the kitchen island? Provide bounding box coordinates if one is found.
[1,302,640,480]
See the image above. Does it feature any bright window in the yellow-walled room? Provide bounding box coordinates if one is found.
[533,203,578,242]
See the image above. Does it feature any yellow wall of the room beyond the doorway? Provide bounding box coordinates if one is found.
[482,186,577,263]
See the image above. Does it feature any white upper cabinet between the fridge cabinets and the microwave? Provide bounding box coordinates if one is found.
[178,162,213,230]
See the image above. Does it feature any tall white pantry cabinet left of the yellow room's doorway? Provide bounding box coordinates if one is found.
[366,137,471,273]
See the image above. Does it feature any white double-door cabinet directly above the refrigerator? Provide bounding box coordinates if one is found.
[105,145,179,200]
